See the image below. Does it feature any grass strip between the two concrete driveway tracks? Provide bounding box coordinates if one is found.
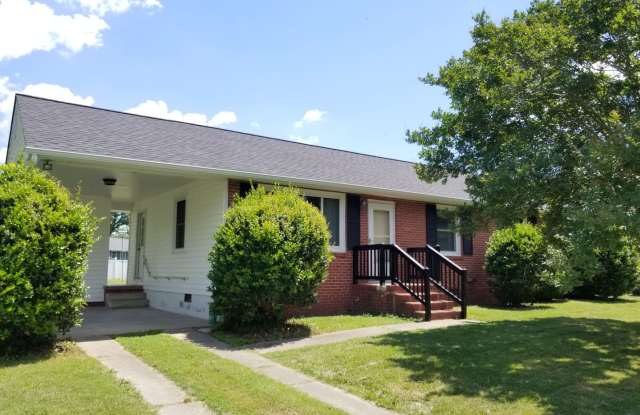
[117,334,342,414]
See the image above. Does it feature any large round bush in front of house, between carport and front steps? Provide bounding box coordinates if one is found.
[209,186,332,330]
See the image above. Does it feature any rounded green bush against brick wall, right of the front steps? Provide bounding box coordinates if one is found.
[485,224,547,306]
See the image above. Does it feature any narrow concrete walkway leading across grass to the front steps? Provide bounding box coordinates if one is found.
[245,320,479,354]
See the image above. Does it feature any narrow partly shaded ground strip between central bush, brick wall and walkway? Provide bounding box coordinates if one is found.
[212,314,413,346]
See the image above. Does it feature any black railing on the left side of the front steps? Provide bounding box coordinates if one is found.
[353,244,431,320]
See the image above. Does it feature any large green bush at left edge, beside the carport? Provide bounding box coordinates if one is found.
[0,163,96,354]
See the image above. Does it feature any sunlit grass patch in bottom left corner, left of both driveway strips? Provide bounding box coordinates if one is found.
[0,343,155,415]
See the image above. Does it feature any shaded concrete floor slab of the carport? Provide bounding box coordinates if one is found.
[69,307,209,340]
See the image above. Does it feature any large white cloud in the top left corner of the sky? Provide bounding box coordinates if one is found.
[0,0,109,61]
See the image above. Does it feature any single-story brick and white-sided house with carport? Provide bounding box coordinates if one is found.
[7,94,489,318]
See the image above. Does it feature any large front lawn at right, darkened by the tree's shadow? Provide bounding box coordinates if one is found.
[268,297,640,415]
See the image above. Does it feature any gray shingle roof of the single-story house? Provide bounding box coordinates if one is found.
[16,95,469,200]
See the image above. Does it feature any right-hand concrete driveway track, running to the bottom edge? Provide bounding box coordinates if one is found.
[173,331,395,415]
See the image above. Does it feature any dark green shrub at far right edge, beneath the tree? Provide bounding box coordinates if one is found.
[573,238,640,298]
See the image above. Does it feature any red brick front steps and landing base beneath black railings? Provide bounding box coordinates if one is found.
[354,282,461,320]
